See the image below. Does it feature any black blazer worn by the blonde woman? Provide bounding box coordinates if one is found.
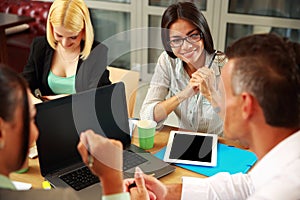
[22,36,111,95]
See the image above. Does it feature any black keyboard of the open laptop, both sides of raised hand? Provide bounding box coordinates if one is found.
[60,151,147,191]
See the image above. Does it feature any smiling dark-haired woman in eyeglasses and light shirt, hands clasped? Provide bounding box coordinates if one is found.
[140,2,225,135]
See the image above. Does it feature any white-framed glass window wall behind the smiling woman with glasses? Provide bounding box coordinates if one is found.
[86,0,300,82]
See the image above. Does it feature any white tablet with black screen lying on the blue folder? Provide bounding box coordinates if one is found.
[164,131,218,166]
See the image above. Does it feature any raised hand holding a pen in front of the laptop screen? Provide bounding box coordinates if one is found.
[77,130,123,195]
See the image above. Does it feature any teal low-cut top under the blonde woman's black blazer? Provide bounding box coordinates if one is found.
[48,70,76,94]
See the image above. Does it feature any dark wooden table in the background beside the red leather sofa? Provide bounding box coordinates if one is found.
[0,13,35,64]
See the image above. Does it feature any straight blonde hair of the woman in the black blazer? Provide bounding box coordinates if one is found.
[46,0,94,60]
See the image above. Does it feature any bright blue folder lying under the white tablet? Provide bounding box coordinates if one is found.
[154,143,257,176]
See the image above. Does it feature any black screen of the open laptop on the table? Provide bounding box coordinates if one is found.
[36,82,131,176]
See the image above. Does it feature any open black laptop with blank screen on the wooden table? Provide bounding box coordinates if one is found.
[36,82,175,199]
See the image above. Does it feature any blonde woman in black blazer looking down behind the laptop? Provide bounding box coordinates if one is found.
[23,0,111,102]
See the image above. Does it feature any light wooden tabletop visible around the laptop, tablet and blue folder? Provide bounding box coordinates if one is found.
[10,126,247,188]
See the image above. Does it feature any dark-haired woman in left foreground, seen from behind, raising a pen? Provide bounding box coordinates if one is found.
[0,67,129,200]
